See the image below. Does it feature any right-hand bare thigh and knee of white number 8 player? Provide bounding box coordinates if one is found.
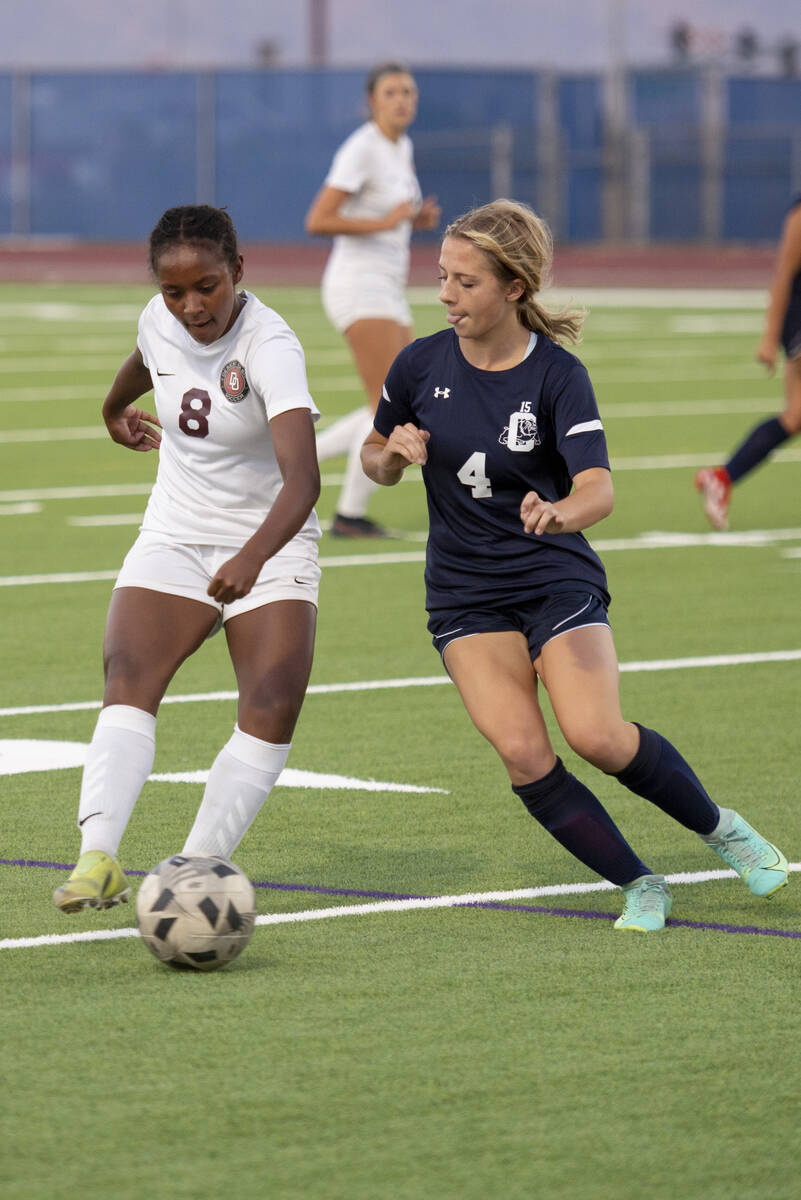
[225,600,317,744]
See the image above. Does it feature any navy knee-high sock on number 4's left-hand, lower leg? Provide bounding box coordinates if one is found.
[512,758,652,887]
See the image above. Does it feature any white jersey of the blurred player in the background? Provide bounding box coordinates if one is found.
[325,121,422,286]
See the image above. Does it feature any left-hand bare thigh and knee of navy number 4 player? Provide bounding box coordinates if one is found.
[444,631,554,784]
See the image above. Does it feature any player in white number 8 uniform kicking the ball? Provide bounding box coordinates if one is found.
[53,205,320,913]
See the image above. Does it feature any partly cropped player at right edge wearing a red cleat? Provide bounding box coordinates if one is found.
[695,196,801,529]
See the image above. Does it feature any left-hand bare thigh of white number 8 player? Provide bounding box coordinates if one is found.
[103,587,217,713]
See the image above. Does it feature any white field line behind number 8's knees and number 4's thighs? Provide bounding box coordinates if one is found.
[0,649,801,716]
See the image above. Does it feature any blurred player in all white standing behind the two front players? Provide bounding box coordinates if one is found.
[306,62,440,538]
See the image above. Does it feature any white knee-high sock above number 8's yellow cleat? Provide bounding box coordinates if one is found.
[78,704,156,858]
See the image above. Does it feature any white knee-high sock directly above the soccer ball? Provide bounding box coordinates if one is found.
[182,725,290,858]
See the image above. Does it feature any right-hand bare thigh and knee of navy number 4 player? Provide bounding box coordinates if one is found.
[534,625,639,772]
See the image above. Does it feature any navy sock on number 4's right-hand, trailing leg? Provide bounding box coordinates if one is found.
[614,725,721,834]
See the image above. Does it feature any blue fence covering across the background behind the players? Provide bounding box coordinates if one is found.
[0,70,801,241]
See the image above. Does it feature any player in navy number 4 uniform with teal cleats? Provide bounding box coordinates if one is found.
[362,200,788,932]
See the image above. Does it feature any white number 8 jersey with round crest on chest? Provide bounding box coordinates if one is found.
[138,292,320,557]
